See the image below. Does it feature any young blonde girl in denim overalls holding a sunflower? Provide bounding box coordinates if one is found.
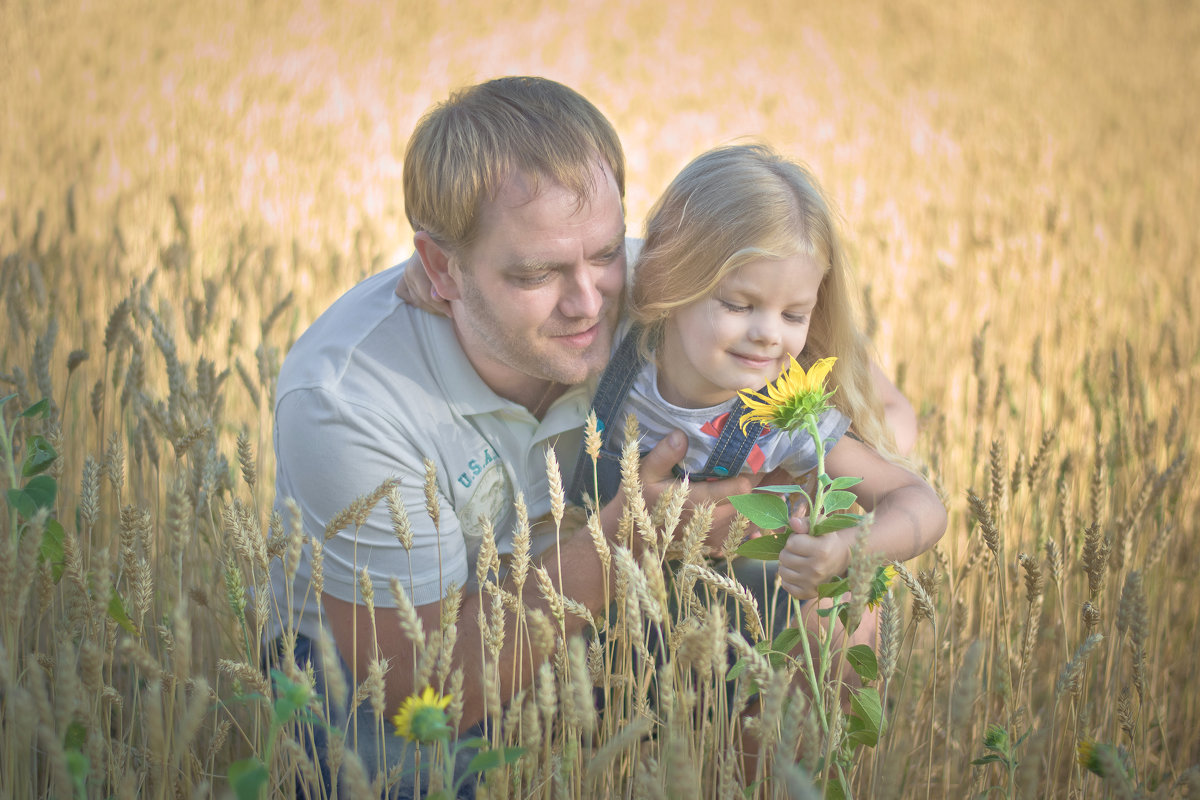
[576,145,946,599]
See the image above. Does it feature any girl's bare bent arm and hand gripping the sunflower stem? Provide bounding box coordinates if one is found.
[779,437,946,599]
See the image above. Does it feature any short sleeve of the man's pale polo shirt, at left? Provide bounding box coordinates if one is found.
[275,387,468,608]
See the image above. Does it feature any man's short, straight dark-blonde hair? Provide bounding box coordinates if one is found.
[404,78,625,252]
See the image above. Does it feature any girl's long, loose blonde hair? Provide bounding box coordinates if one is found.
[630,144,898,459]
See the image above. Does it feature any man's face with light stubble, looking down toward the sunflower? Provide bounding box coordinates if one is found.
[450,164,625,408]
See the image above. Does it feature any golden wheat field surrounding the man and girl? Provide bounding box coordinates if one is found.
[0,0,1200,799]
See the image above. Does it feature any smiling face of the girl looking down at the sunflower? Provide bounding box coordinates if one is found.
[659,254,824,408]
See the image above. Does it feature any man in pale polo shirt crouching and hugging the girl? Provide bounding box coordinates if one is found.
[272,78,750,796]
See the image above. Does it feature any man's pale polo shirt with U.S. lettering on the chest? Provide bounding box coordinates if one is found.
[271,266,594,636]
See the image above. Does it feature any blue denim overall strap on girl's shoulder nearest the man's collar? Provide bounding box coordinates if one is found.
[569,325,646,506]
